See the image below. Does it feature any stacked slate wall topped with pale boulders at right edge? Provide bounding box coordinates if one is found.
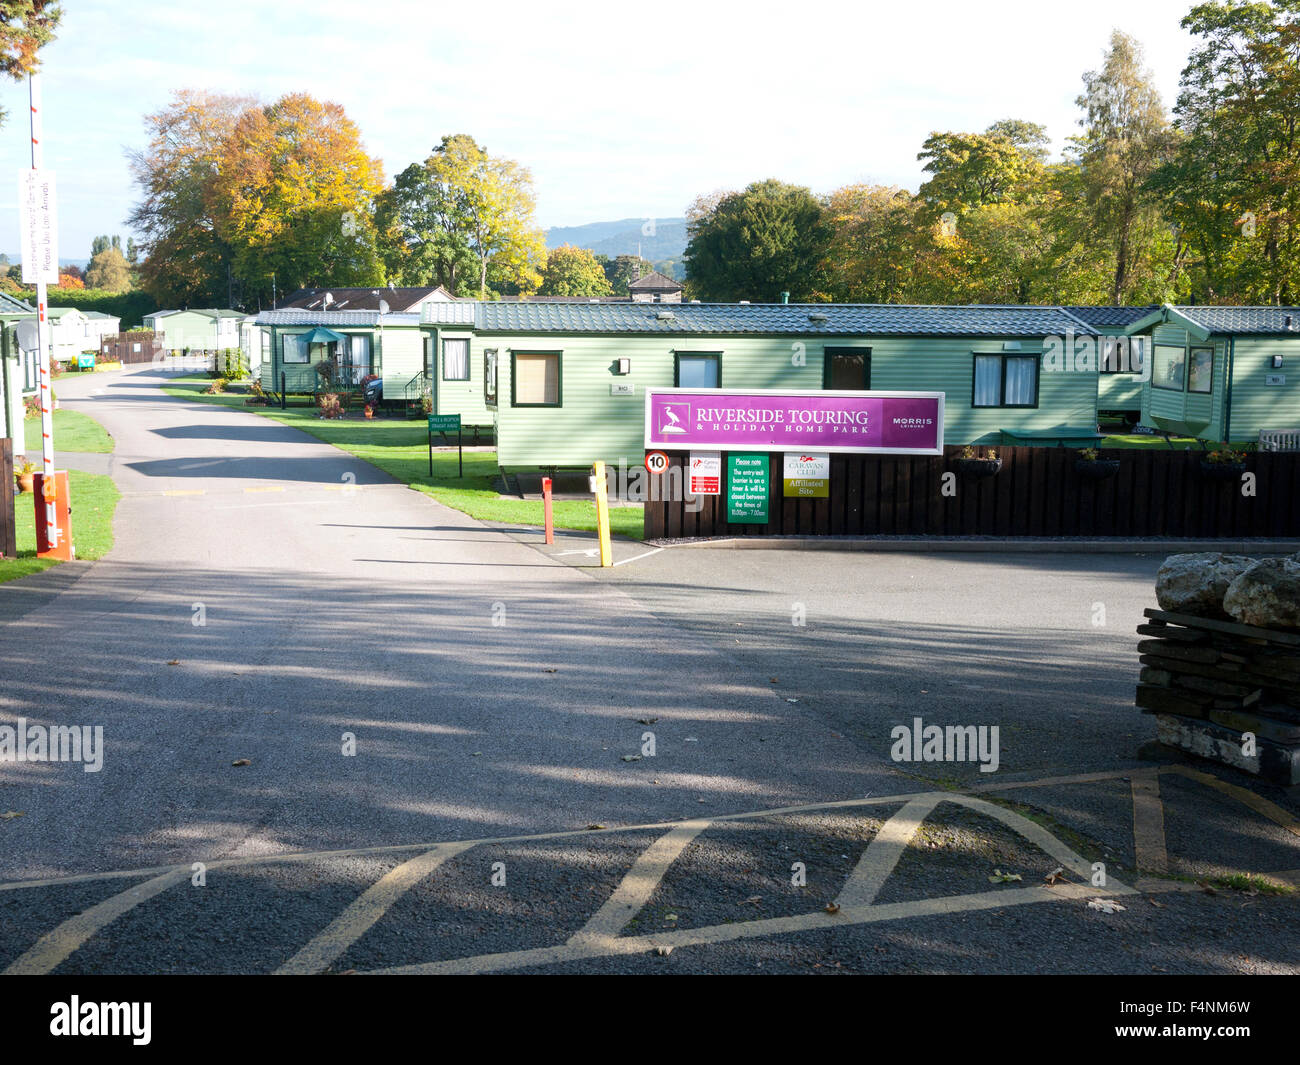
[1136,554,1300,785]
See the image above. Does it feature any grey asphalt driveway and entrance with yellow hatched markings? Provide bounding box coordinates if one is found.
[0,371,1300,971]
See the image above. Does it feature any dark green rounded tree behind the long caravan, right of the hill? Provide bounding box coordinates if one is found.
[686,179,826,302]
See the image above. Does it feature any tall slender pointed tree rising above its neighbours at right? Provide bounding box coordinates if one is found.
[1074,30,1174,304]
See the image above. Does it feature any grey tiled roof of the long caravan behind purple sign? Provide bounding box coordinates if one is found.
[434,300,1096,337]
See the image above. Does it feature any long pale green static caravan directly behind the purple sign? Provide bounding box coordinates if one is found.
[424,302,1099,469]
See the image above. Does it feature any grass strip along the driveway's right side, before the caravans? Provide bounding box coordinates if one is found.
[163,376,644,540]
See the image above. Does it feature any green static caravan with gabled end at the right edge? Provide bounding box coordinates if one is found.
[1128,304,1300,447]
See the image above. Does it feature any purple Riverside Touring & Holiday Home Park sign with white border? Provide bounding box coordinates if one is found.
[646,389,944,455]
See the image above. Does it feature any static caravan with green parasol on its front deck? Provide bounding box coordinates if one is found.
[254,311,424,399]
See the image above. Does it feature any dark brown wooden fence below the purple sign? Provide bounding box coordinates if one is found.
[645,447,1300,538]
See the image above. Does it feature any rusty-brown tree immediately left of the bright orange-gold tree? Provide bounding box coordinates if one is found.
[127,90,254,307]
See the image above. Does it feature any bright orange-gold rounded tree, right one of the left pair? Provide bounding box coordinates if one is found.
[209,94,384,304]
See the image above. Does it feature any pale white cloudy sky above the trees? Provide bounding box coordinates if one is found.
[0,0,1191,257]
